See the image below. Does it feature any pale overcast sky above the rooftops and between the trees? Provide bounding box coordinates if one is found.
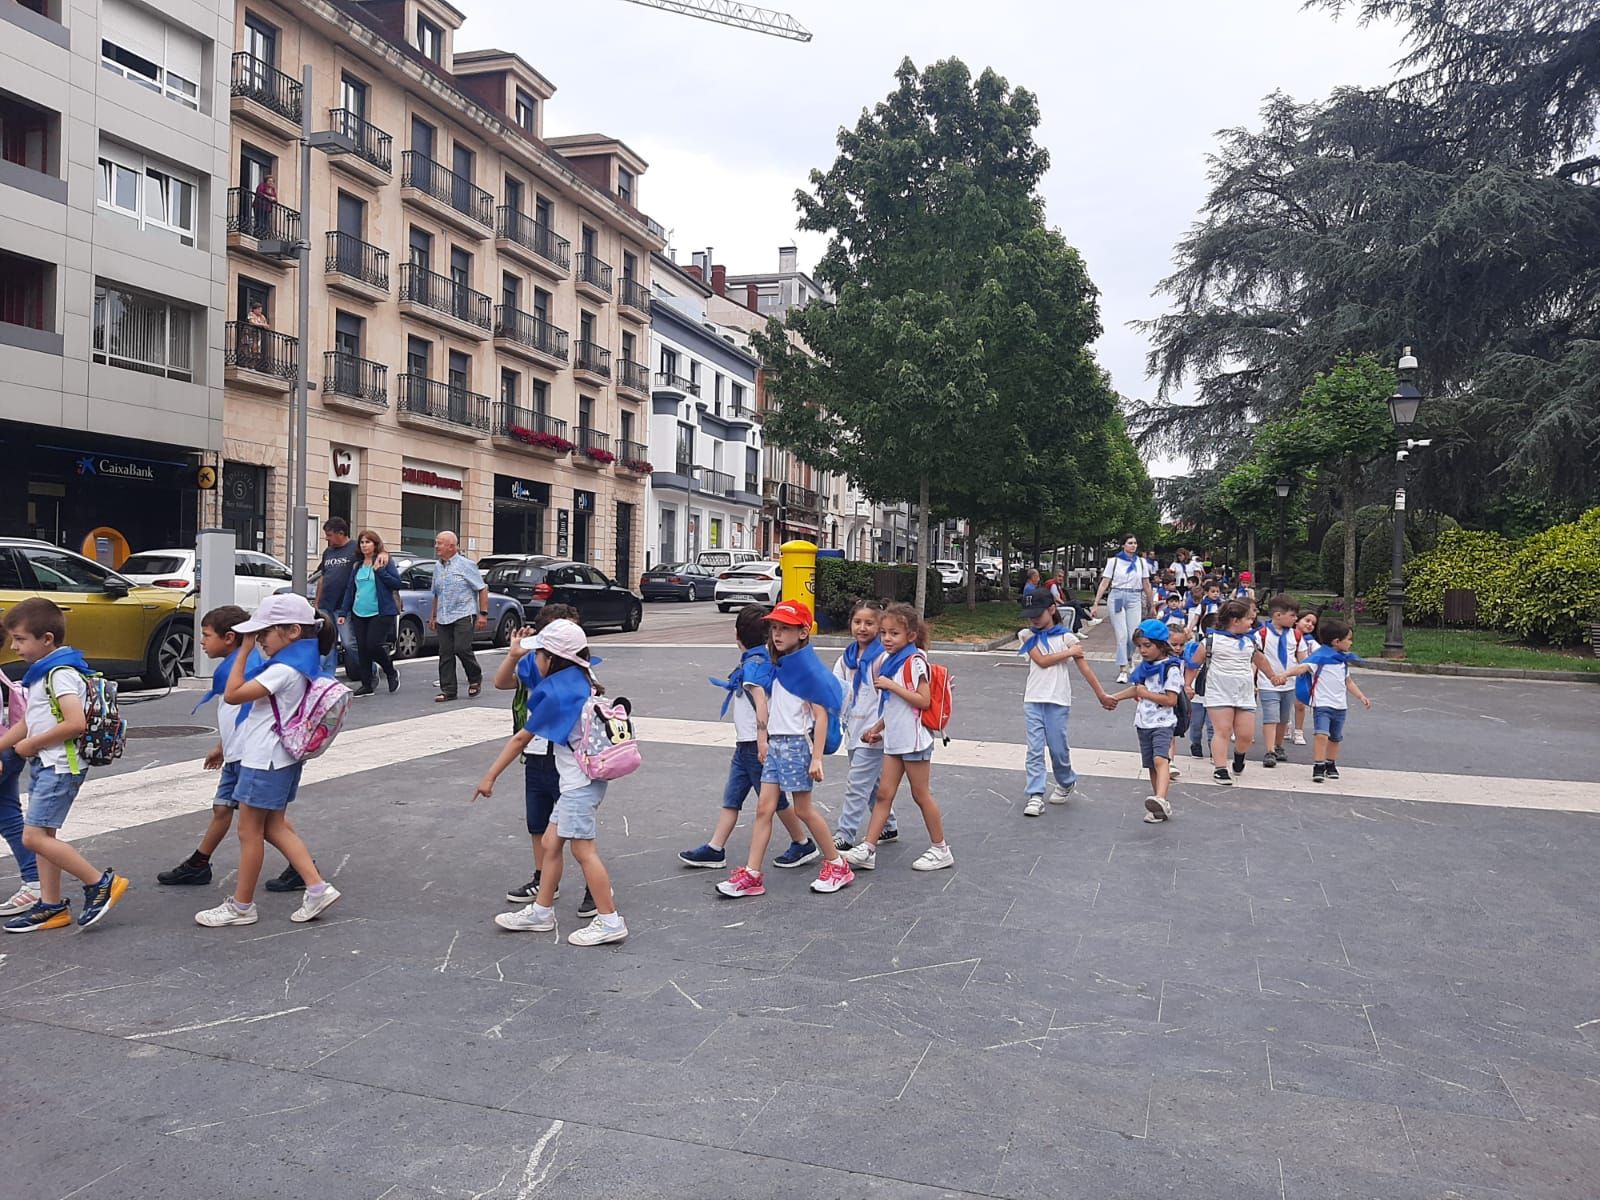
[454,0,1402,475]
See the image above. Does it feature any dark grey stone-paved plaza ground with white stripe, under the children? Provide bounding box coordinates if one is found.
[0,633,1600,1200]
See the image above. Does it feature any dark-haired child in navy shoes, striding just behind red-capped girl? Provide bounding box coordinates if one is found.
[678,605,822,867]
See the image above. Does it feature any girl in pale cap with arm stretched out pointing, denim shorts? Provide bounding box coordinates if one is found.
[472,618,627,946]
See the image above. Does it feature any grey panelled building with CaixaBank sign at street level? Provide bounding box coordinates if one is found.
[0,0,234,565]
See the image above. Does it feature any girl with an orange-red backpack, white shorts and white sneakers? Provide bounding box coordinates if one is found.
[845,597,947,870]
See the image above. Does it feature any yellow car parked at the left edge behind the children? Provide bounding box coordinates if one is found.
[0,538,195,688]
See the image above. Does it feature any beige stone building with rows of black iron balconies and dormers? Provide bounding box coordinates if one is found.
[222,0,662,579]
